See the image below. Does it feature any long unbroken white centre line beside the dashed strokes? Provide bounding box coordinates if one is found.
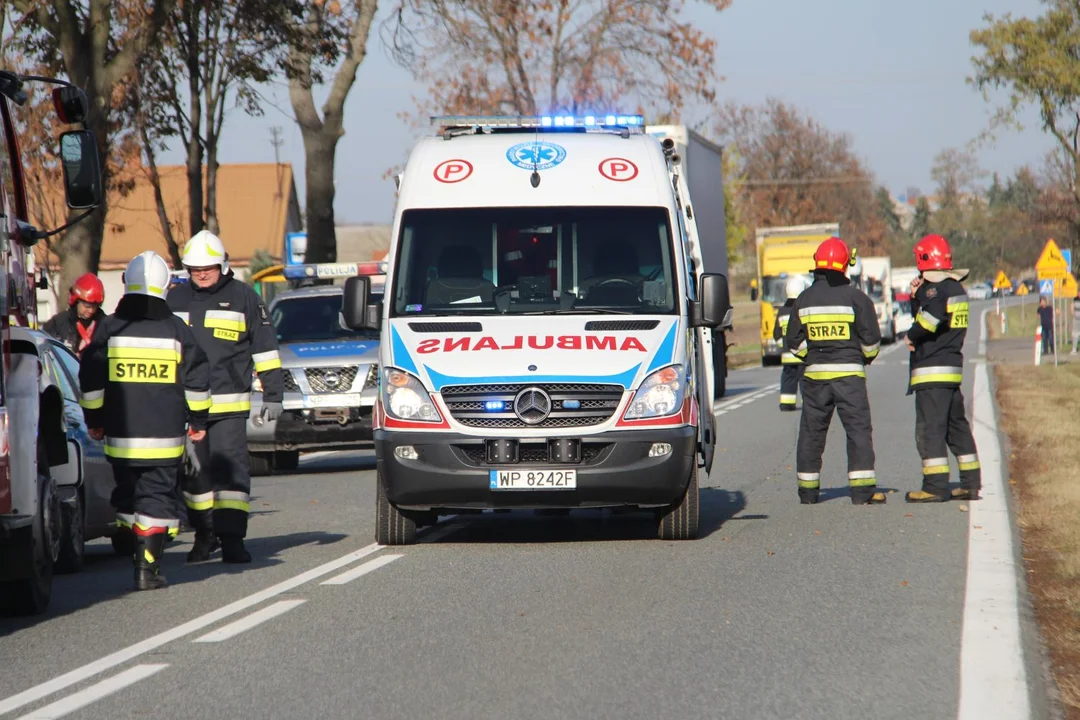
[0,543,383,715]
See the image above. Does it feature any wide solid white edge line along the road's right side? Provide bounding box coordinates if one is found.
[958,367,1031,720]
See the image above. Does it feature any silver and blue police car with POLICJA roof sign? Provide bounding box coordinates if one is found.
[247,262,386,475]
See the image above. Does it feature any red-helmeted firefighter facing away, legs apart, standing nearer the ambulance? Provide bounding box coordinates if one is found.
[785,237,886,505]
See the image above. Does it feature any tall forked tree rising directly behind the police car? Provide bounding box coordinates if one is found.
[288,0,378,262]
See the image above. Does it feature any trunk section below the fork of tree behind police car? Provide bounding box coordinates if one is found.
[302,128,340,262]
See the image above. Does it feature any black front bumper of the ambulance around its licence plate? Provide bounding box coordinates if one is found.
[375,426,697,510]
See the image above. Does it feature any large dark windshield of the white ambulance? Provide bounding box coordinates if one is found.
[393,207,679,316]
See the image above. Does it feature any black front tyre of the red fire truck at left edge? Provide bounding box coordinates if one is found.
[0,474,59,615]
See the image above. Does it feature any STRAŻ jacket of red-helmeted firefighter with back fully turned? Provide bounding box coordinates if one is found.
[784,270,881,380]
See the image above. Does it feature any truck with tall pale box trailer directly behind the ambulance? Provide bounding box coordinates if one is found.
[645,125,731,399]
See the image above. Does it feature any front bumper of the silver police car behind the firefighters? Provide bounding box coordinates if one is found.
[247,395,372,452]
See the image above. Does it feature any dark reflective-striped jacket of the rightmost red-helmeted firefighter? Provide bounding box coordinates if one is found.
[907,277,968,392]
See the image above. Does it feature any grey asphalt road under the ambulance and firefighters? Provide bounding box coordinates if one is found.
[0,303,1042,720]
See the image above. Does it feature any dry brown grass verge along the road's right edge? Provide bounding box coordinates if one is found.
[996,365,1080,720]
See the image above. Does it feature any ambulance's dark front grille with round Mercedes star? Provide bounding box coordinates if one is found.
[443,383,623,430]
